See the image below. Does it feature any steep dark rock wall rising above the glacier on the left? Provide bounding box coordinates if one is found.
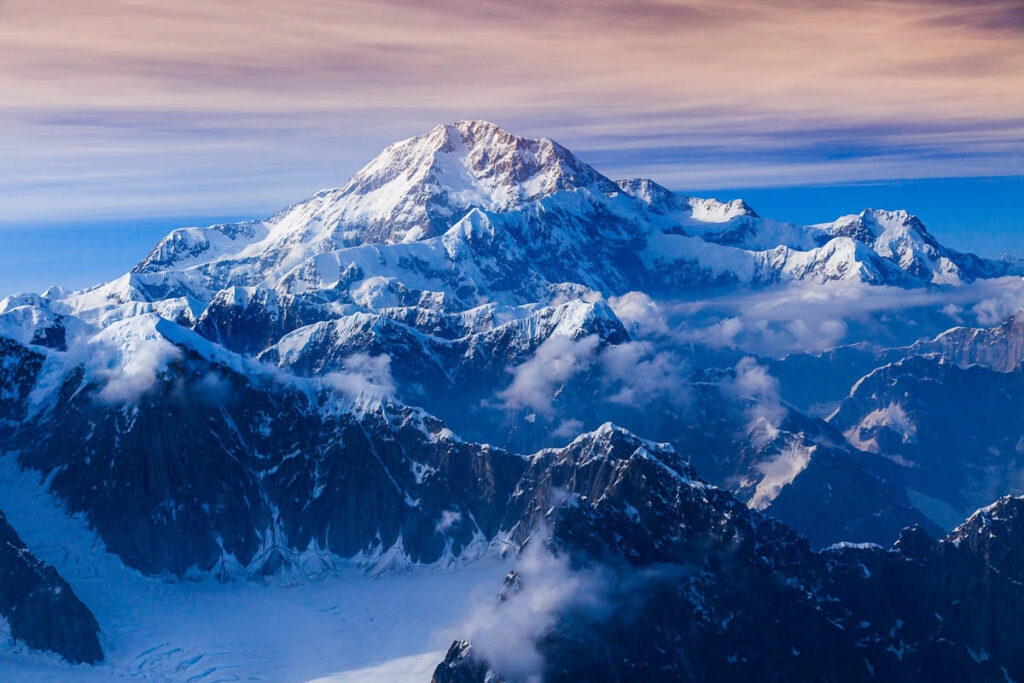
[7,337,525,575]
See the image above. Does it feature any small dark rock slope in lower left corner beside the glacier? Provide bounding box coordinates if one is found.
[0,512,103,664]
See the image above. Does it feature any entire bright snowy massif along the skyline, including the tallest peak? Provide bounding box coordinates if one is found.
[44,122,1019,323]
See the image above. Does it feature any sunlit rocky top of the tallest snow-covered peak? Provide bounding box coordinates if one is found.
[264,121,617,247]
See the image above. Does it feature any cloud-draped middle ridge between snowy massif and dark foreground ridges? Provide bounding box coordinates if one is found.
[249,301,939,546]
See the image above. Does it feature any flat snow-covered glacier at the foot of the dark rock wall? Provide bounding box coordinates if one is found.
[0,450,510,682]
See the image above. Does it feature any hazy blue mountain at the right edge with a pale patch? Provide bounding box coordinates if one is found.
[829,356,1024,528]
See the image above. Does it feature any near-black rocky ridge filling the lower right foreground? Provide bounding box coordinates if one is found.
[435,481,1024,681]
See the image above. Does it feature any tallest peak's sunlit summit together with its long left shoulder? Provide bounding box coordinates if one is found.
[135,121,617,282]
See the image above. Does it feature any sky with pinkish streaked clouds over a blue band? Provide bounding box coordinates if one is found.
[0,0,1024,292]
